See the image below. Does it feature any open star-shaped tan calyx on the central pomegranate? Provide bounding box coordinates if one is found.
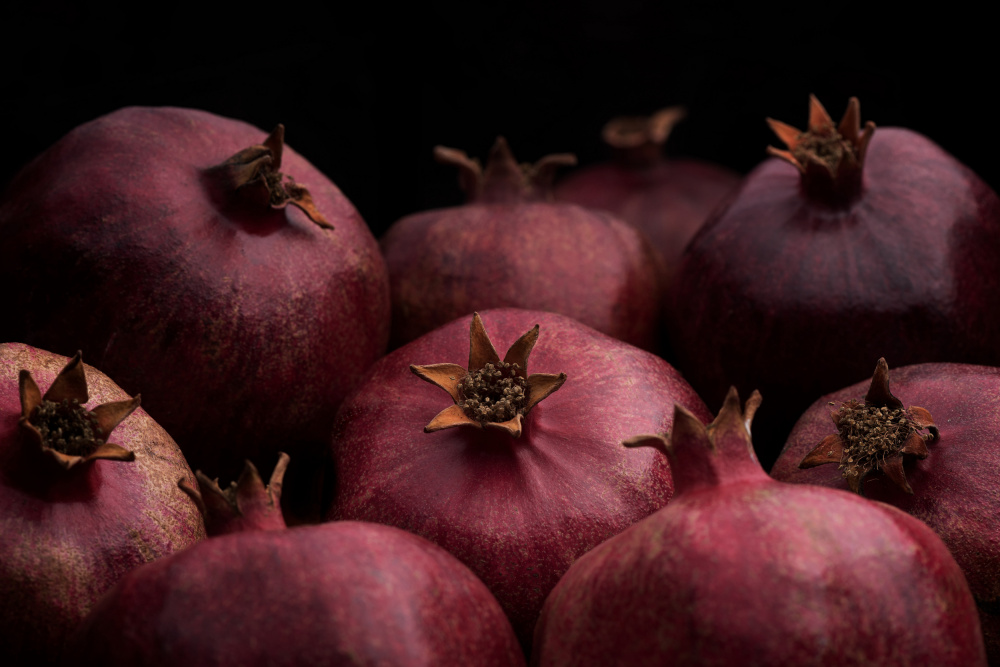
[410,313,566,438]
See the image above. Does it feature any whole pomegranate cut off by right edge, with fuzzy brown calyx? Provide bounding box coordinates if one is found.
[771,359,1000,664]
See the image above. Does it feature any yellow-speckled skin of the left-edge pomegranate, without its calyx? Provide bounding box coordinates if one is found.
[0,344,205,665]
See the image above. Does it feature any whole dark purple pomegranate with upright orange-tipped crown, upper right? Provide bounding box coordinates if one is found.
[668,98,1000,467]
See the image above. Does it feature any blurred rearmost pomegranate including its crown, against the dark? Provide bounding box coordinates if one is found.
[555,107,741,283]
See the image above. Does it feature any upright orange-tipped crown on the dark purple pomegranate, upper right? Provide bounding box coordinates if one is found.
[767,95,875,203]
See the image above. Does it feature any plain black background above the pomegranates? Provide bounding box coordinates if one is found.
[0,0,984,240]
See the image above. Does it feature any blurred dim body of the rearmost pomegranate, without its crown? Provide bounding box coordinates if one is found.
[555,159,741,290]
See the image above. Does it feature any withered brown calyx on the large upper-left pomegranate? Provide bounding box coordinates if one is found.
[209,125,333,229]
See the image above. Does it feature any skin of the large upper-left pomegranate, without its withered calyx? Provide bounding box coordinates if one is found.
[0,107,389,477]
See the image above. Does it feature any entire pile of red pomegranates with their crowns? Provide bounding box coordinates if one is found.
[0,97,1000,667]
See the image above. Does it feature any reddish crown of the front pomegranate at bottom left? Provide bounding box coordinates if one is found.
[177,452,289,536]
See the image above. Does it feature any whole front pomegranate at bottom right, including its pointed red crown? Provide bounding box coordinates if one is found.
[532,389,986,667]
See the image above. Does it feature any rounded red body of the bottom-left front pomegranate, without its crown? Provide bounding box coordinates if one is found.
[72,522,524,667]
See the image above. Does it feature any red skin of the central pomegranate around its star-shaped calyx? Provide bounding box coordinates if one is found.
[330,309,710,649]
